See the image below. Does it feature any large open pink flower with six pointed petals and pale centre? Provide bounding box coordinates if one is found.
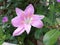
[11,4,44,36]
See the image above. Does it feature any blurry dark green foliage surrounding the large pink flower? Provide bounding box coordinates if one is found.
[0,0,60,45]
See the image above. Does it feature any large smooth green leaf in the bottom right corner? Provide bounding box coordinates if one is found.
[43,29,60,45]
